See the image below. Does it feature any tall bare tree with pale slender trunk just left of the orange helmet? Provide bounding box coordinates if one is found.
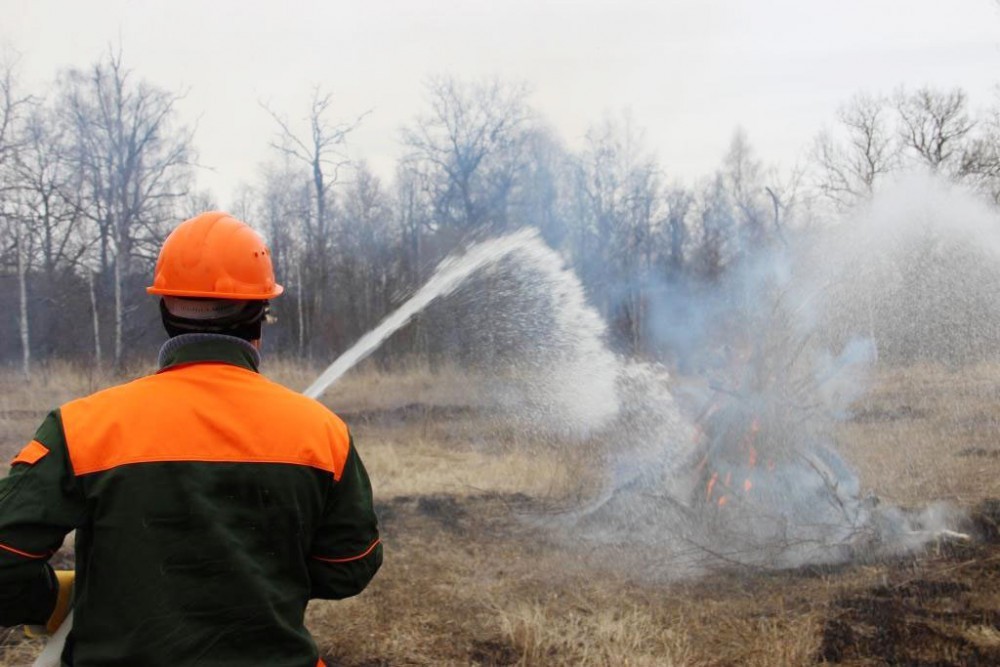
[60,52,193,368]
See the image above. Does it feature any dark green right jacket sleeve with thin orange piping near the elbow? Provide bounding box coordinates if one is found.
[309,439,382,600]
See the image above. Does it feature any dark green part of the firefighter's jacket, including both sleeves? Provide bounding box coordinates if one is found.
[0,337,382,667]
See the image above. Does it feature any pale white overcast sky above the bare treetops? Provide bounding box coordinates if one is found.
[0,0,1000,206]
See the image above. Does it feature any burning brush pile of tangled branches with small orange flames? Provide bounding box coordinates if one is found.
[686,336,879,567]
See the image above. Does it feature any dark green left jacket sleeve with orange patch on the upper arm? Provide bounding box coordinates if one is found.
[0,411,85,626]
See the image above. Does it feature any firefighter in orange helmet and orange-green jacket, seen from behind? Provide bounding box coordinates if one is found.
[0,212,382,667]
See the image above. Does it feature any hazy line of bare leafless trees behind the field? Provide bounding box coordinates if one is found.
[0,54,1000,374]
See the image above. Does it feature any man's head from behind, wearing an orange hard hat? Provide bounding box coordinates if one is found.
[146,211,284,341]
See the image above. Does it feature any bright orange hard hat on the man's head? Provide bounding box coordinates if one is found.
[146,211,284,300]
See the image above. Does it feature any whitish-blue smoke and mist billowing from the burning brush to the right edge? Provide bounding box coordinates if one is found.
[544,177,1000,575]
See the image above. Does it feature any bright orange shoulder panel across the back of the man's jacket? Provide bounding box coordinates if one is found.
[60,363,350,480]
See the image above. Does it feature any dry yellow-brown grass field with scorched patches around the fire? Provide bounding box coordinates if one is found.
[0,363,1000,667]
